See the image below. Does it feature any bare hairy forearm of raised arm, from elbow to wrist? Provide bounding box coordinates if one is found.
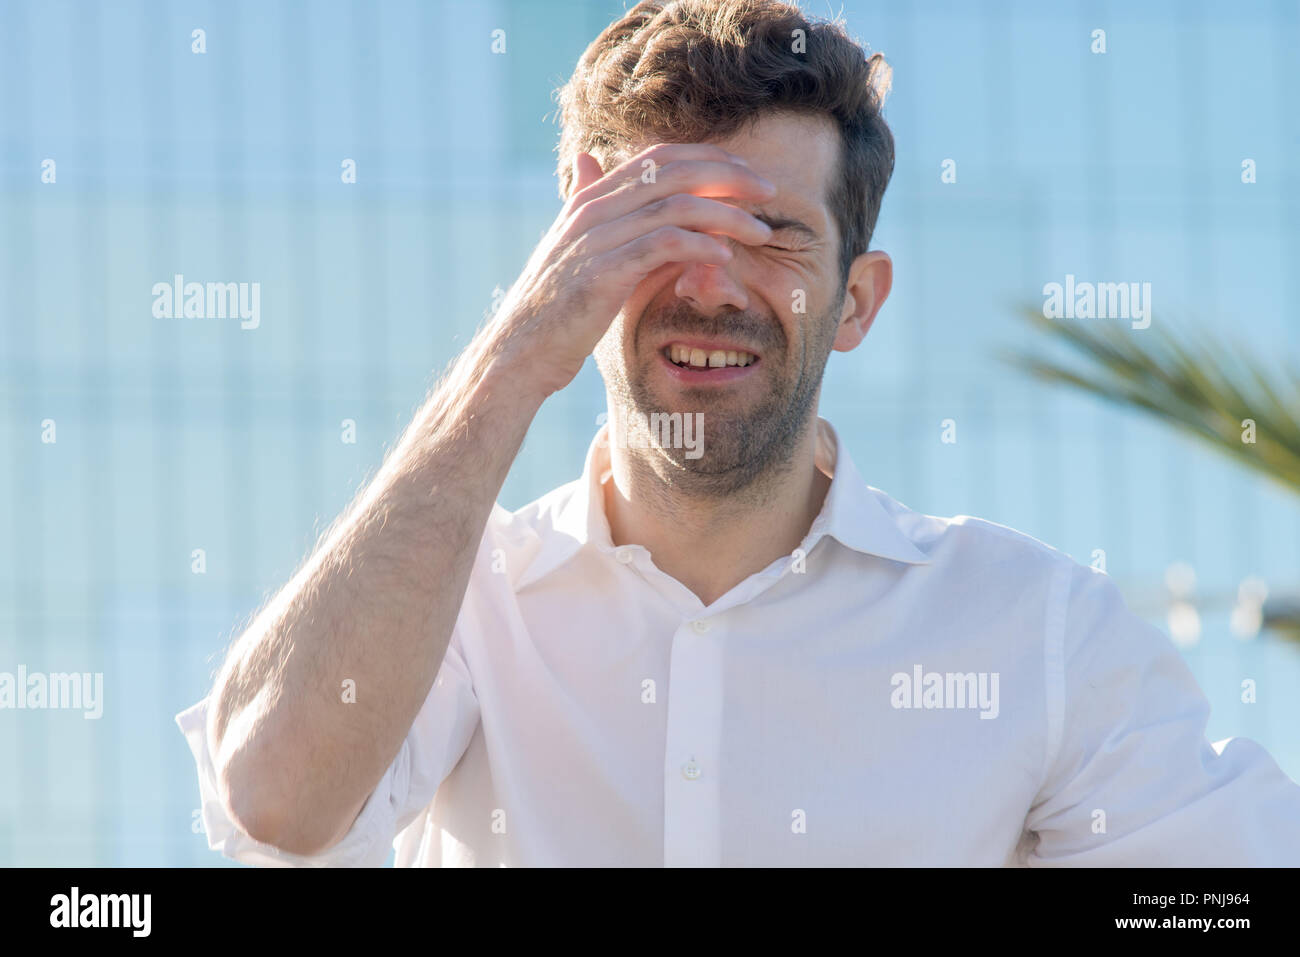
[209,327,541,853]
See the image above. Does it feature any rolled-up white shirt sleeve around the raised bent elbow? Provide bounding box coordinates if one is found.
[176,625,478,867]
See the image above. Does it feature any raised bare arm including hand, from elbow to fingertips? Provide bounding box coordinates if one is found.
[208,144,774,854]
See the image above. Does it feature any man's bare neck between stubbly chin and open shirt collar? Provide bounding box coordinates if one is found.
[603,419,831,606]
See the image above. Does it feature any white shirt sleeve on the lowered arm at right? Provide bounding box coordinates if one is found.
[1024,562,1300,867]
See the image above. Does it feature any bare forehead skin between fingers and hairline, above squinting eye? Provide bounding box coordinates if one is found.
[715,113,840,234]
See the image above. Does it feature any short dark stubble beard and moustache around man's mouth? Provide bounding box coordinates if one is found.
[595,290,844,498]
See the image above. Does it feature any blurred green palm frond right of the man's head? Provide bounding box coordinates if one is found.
[1001,307,1300,493]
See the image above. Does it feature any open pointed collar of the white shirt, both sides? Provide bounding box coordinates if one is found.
[516,417,930,588]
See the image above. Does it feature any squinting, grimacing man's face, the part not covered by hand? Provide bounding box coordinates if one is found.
[594,114,845,495]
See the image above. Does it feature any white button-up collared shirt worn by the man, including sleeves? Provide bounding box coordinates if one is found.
[177,420,1300,867]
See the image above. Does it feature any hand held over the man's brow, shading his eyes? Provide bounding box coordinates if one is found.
[497,144,776,399]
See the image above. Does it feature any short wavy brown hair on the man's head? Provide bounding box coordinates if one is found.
[558,0,894,282]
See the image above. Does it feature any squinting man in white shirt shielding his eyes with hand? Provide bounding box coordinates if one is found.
[178,0,1300,866]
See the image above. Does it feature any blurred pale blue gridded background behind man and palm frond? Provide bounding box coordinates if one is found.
[0,0,1300,866]
